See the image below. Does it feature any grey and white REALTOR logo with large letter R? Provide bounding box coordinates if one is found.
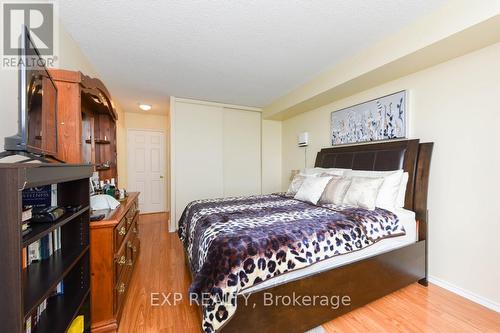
[1,0,58,68]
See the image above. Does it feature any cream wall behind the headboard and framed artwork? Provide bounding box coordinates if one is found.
[282,40,500,311]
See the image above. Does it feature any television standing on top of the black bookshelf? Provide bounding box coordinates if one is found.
[4,27,57,156]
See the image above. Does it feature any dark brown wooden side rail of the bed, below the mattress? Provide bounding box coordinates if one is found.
[219,240,426,333]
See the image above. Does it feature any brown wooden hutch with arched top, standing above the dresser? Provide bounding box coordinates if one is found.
[50,69,118,179]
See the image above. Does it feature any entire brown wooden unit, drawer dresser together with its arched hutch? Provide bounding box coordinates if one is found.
[50,69,140,333]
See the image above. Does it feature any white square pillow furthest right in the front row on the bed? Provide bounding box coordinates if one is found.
[343,177,384,210]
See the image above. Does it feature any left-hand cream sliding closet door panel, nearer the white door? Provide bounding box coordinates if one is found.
[172,103,224,220]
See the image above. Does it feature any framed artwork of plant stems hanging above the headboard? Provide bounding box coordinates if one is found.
[330,90,408,146]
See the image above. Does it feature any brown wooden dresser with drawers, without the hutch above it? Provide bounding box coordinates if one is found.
[90,193,140,332]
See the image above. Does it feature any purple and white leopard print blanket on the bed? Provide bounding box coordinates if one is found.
[179,194,405,333]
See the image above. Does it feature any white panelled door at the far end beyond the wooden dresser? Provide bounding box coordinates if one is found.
[127,129,166,213]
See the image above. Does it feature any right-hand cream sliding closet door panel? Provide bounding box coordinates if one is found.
[223,108,261,197]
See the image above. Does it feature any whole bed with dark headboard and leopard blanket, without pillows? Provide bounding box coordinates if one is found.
[179,140,433,333]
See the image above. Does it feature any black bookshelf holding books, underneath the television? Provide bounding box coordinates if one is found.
[0,164,93,333]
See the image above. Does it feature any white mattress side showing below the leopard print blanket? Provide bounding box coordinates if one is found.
[241,208,417,294]
